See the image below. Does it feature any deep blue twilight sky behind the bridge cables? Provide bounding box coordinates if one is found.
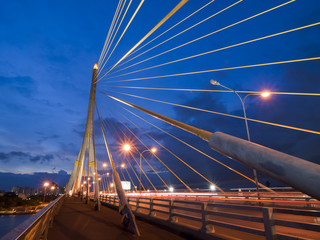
[0,0,320,190]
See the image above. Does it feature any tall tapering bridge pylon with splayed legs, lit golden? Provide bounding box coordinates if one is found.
[66,64,100,210]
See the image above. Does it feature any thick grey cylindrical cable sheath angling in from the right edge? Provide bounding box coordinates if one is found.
[209,132,320,200]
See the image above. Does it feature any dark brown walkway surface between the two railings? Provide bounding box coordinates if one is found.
[48,198,185,240]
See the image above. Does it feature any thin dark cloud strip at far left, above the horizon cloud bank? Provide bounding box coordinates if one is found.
[0,151,54,163]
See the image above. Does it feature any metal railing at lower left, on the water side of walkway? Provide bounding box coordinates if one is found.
[0,195,65,240]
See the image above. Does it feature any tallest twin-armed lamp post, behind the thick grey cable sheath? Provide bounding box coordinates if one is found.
[210,79,270,198]
